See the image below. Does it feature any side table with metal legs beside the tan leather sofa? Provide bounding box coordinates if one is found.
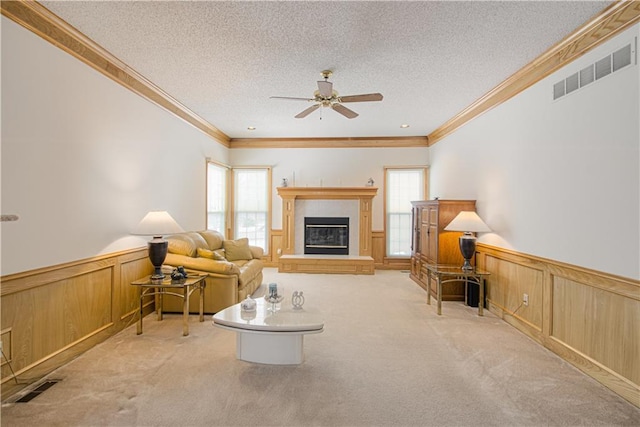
[131,275,207,336]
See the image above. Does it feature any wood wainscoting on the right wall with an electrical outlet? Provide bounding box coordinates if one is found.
[476,244,640,407]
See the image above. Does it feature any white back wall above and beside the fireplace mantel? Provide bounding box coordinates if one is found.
[229,147,429,231]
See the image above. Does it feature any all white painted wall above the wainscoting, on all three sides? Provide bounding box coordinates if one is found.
[5,12,640,278]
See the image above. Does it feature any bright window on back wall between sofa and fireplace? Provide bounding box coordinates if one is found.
[233,168,271,253]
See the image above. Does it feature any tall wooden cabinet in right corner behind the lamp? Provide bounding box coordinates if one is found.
[410,200,476,301]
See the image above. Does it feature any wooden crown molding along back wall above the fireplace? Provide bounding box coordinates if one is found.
[229,136,428,148]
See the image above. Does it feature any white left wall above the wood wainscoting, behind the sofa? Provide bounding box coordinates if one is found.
[0,17,228,275]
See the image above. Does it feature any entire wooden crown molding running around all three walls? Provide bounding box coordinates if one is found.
[0,0,640,148]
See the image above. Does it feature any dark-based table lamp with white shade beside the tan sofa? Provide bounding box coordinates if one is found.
[132,211,184,280]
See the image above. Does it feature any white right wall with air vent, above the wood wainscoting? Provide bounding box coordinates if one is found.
[430,25,640,279]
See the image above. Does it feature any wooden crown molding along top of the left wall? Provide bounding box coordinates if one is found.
[0,0,229,147]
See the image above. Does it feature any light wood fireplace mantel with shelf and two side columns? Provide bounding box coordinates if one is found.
[277,187,378,257]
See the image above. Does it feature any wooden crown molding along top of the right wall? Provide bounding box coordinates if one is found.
[428,0,640,146]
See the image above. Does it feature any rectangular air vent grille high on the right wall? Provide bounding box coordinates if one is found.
[553,37,638,100]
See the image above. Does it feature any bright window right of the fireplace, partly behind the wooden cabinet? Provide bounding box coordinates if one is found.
[384,167,426,257]
